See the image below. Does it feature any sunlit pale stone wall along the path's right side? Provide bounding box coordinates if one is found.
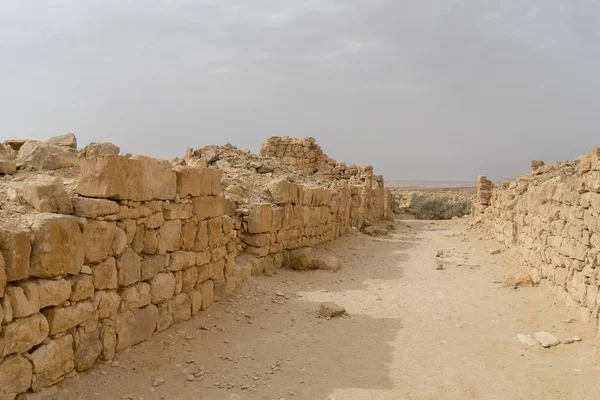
[473,148,600,332]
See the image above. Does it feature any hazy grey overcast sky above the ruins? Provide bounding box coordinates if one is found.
[0,0,600,180]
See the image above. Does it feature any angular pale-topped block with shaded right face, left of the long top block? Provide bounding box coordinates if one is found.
[18,175,73,214]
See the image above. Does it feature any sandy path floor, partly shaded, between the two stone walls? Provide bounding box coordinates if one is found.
[59,221,600,400]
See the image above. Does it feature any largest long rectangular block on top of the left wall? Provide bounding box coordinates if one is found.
[77,155,177,201]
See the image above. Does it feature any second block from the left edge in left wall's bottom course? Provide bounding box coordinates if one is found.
[31,335,75,392]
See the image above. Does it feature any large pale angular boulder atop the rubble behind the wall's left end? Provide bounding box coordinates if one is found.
[16,140,79,170]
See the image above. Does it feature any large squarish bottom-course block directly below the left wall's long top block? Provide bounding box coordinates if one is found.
[115,305,158,352]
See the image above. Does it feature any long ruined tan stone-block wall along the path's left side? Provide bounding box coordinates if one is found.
[0,134,390,399]
